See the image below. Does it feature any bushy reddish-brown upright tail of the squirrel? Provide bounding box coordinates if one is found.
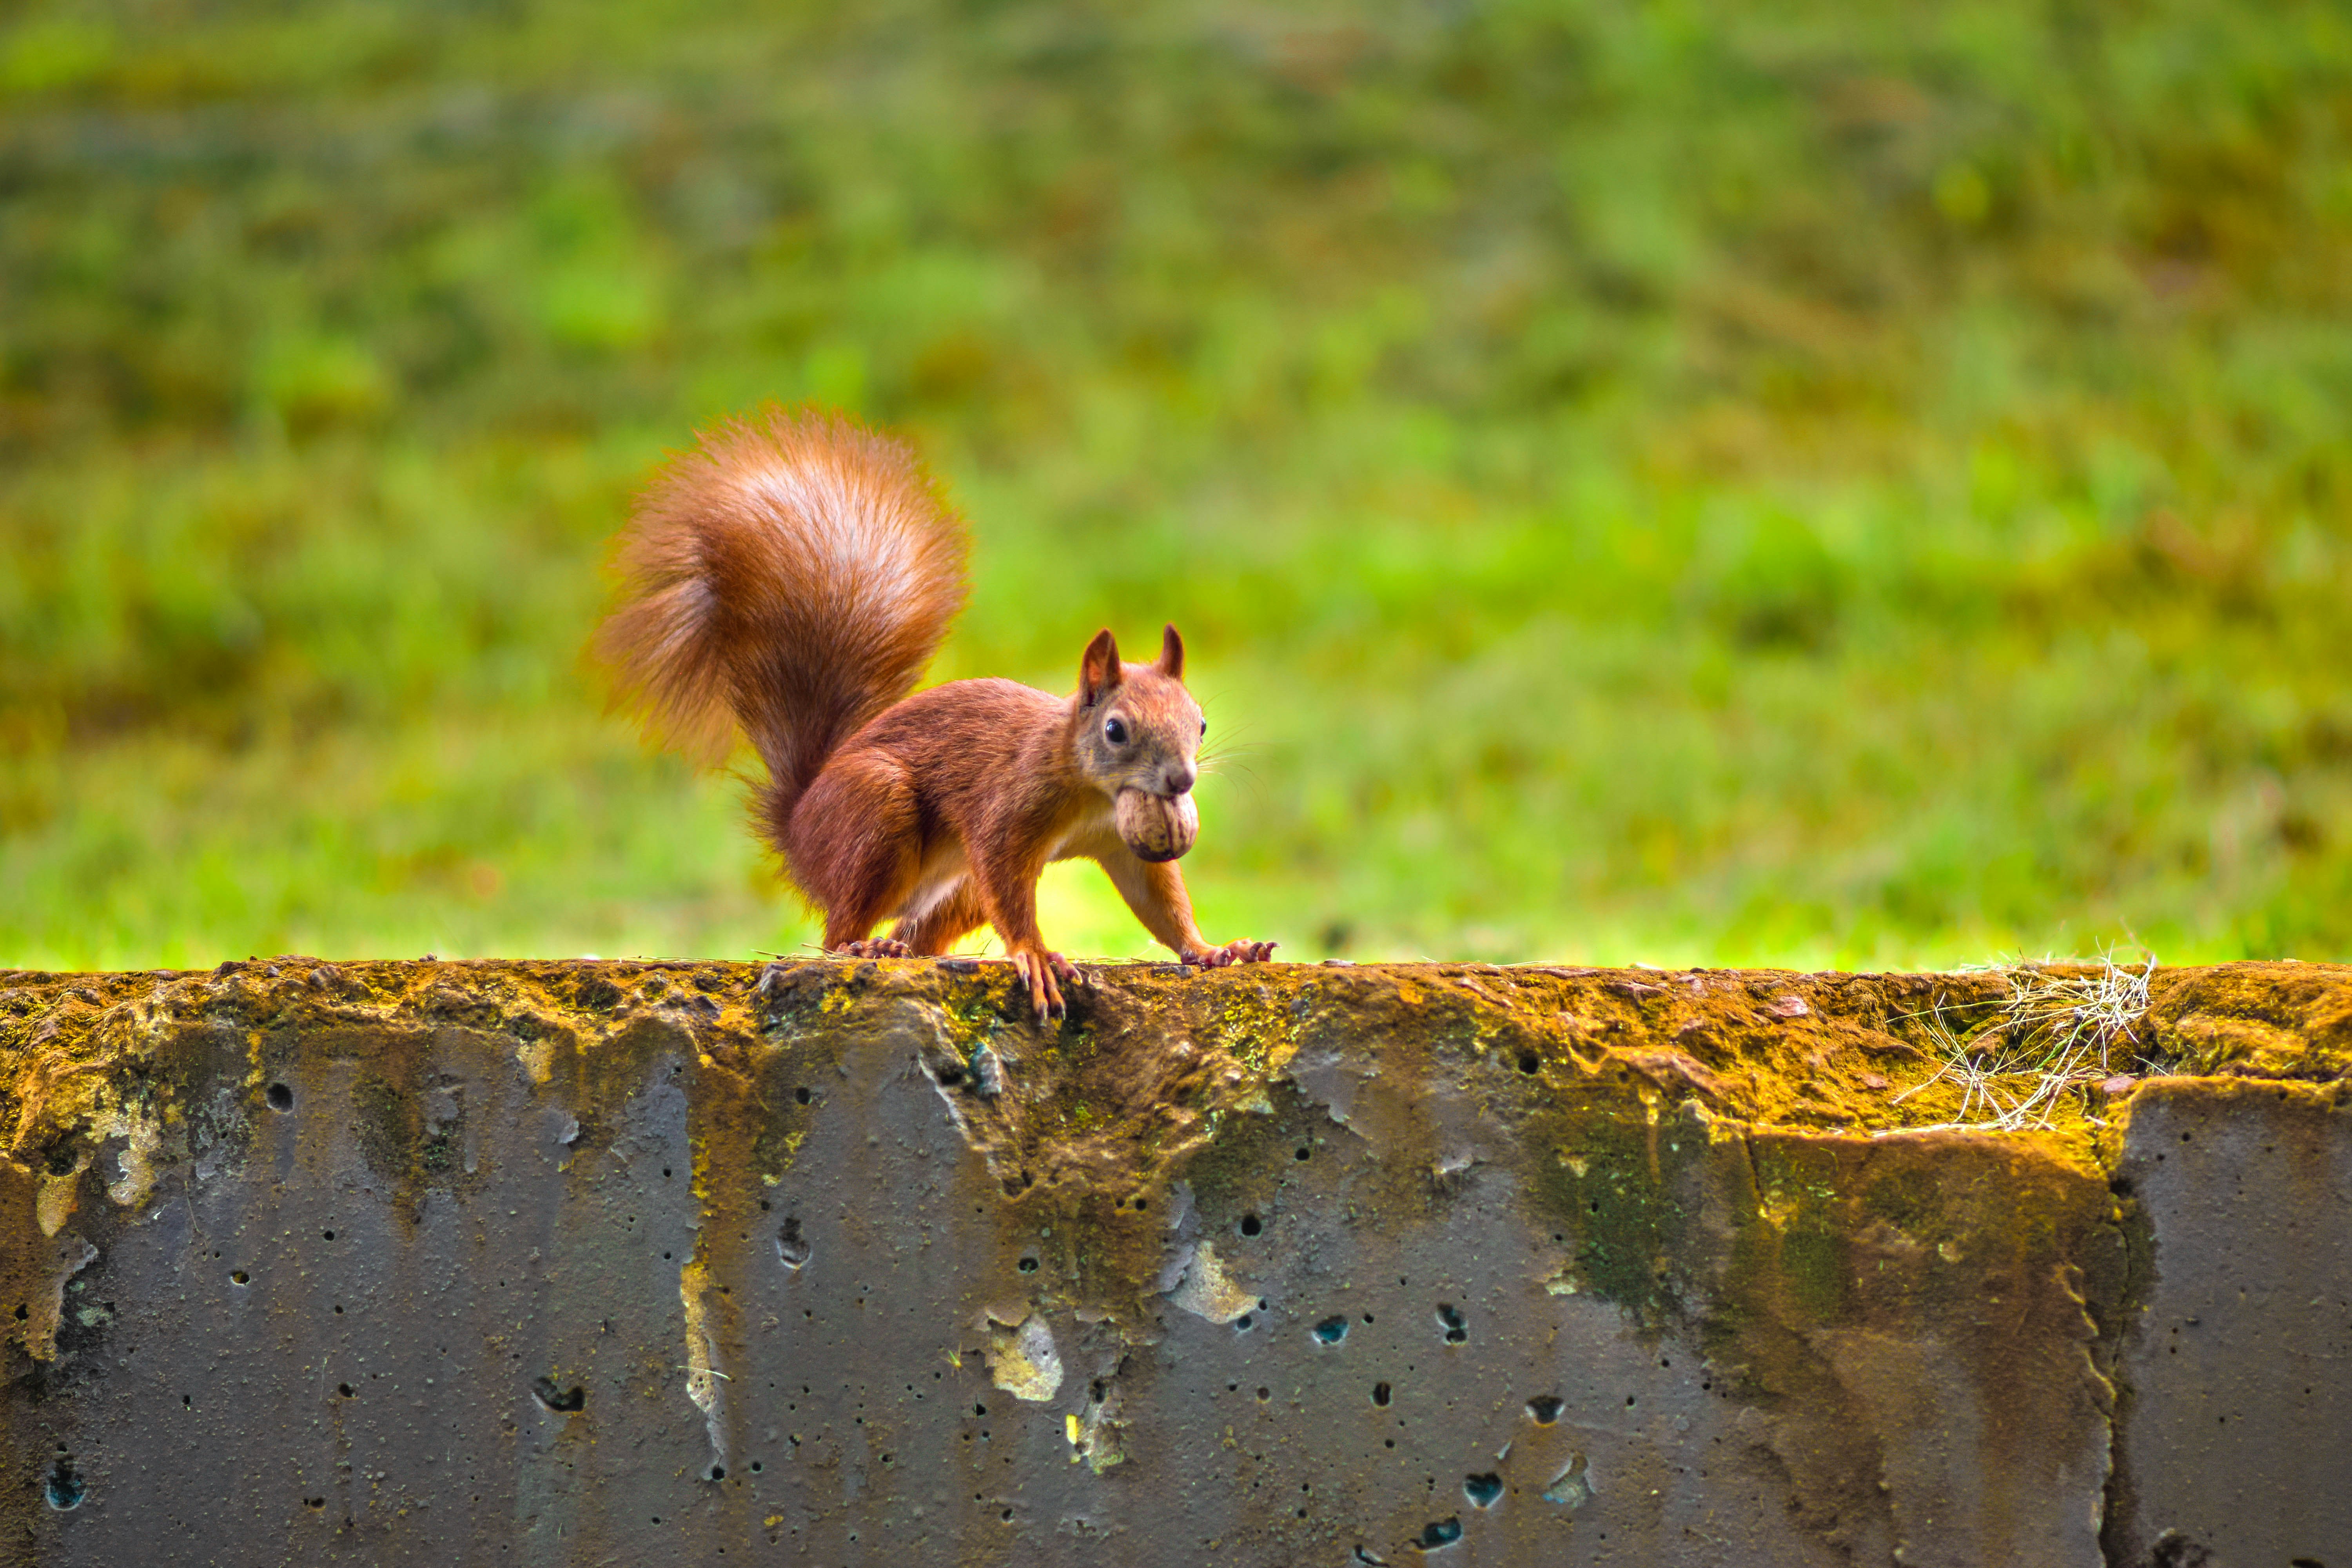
[595,404,969,825]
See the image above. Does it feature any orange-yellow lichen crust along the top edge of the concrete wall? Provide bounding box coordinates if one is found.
[0,959,2352,1180]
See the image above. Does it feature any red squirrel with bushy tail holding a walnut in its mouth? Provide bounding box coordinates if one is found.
[597,404,1275,1020]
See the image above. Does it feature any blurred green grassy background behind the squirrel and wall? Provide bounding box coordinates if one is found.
[0,0,2352,966]
